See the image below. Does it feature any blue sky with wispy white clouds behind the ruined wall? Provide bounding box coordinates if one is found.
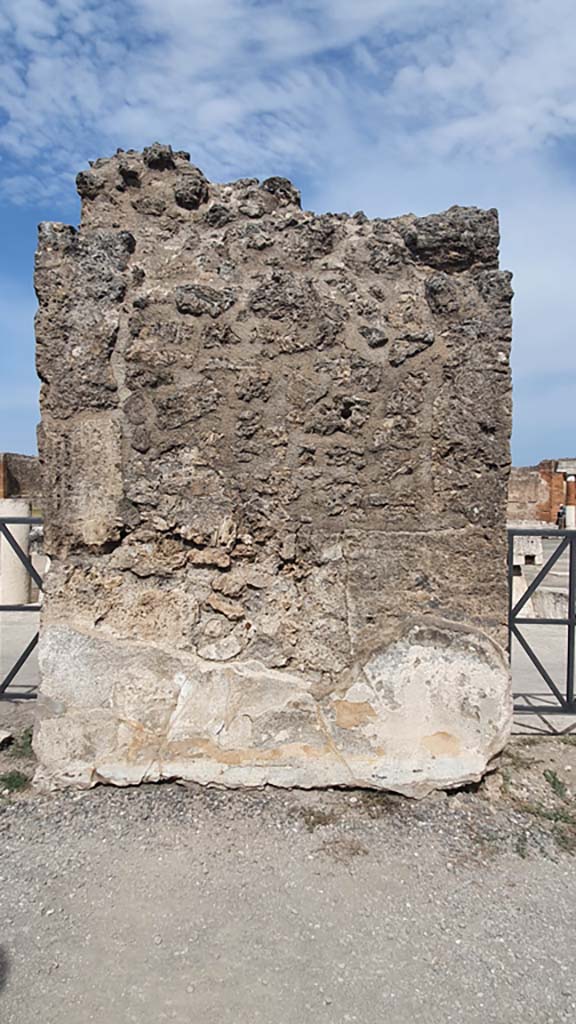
[0,0,576,464]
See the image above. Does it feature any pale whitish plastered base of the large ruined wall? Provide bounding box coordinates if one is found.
[35,623,511,797]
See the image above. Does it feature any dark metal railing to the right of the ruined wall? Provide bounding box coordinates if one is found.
[508,527,576,714]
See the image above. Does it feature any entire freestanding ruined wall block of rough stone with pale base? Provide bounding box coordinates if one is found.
[35,143,512,796]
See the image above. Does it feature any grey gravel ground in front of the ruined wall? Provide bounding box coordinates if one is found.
[0,733,576,1024]
